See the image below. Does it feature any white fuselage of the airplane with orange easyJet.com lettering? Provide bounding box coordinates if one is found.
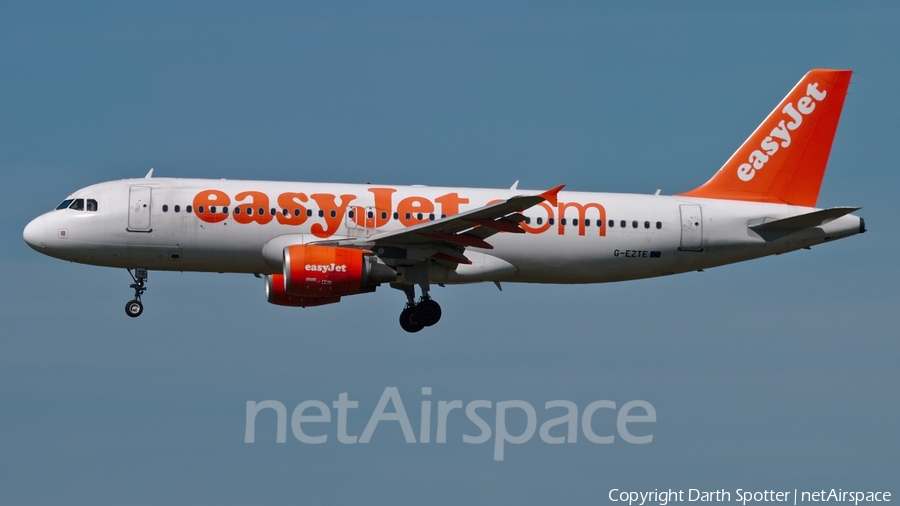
[24,178,863,283]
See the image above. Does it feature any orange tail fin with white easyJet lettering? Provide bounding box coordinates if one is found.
[682,69,852,207]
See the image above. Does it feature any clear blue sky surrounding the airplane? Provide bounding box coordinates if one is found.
[0,2,900,504]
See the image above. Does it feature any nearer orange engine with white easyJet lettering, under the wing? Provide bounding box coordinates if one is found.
[284,244,397,297]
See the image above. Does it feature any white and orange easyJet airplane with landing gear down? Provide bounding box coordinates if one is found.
[23,69,866,332]
